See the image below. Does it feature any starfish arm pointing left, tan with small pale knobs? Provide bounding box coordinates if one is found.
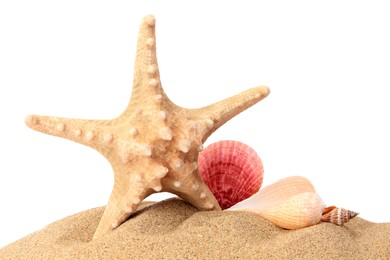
[25,115,112,150]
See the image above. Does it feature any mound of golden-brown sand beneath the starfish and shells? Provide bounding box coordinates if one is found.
[0,199,390,259]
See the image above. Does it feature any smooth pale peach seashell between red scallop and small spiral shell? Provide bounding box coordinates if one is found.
[228,176,324,229]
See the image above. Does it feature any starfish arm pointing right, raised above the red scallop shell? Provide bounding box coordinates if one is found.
[191,87,270,143]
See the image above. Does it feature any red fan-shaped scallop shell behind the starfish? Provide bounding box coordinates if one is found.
[198,140,264,209]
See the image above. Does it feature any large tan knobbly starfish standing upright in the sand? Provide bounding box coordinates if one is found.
[26,16,269,239]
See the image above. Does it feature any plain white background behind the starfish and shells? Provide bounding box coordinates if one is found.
[0,1,390,246]
